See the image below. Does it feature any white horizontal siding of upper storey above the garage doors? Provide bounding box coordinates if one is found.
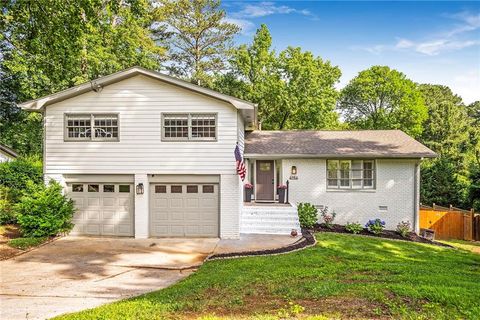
[45,76,238,175]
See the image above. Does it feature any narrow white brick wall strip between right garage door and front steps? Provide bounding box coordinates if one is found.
[220,174,242,239]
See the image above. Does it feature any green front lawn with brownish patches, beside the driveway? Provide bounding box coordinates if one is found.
[53,233,480,319]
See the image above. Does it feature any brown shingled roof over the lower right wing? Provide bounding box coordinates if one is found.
[245,130,437,158]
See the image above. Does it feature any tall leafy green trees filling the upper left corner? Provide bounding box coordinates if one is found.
[0,0,166,154]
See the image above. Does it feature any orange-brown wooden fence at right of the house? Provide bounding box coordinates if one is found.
[420,204,480,240]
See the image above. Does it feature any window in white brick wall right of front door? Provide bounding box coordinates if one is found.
[327,160,375,189]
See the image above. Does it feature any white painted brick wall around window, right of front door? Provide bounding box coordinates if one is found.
[282,159,415,229]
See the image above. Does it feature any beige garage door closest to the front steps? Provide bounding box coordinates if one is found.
[150,183,219,237]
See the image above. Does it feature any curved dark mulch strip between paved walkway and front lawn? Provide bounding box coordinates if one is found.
[207,229,316,260]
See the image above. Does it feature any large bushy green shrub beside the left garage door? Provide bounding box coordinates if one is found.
[15,181,75,237]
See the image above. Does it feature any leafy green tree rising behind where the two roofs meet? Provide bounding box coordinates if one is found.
[215,25,341,130]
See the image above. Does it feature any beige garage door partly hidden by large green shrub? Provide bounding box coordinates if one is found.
[68,183,134,236]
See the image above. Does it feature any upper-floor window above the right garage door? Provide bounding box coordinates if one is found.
[162,113,217,141]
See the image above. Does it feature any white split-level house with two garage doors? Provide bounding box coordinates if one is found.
[20,67,435,238]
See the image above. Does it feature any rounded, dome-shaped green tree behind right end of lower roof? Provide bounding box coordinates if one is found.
[338,66,427,137]
